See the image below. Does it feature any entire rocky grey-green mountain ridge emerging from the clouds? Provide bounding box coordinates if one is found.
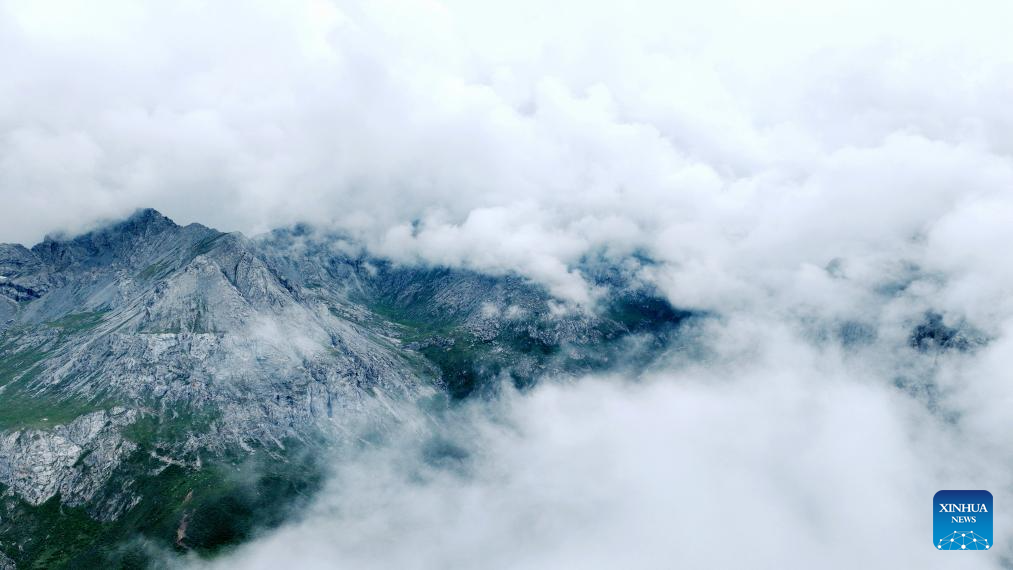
[0,210,692,568]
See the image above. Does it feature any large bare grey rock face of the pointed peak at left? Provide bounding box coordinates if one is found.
[0,211,435,517]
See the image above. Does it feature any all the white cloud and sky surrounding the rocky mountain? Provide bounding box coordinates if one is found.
[0,0,1013,568]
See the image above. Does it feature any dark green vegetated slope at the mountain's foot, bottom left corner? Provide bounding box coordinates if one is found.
[0,442,323,569]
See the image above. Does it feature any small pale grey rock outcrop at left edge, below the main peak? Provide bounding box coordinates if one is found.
[0,408,137,506]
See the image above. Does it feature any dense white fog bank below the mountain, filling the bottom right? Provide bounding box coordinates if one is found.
[190,324,1009,569]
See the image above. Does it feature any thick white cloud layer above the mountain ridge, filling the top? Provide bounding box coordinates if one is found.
[0,0,1013,307]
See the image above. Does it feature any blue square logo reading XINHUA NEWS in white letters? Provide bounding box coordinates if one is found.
[932,491,993,550]
